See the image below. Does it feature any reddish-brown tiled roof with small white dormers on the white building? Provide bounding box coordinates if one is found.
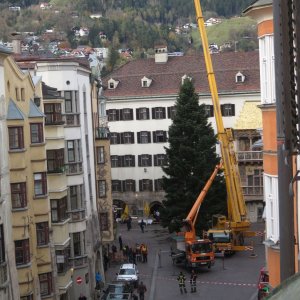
[102,51,260,97]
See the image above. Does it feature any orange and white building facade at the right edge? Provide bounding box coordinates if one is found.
[245,0,280,287]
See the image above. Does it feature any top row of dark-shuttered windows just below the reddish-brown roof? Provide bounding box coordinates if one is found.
[106,103,235,121]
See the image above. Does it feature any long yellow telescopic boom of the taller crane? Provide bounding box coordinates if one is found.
[194,0,250,229]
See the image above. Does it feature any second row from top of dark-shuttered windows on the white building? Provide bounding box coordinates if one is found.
[110,130,168,145]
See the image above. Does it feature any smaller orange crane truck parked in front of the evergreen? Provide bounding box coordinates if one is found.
[171,165,221,269]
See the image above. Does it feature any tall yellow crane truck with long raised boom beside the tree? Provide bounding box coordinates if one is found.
[194,0,255,254]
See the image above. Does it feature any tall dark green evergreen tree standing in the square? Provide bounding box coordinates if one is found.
[161,79,226,232]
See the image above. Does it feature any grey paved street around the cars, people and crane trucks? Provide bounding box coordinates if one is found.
[106,221,265,300]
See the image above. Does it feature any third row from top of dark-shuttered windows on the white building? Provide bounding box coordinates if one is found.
[110,154,167,168]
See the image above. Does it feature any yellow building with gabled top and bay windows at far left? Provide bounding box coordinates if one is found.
[3,50,54,300]
